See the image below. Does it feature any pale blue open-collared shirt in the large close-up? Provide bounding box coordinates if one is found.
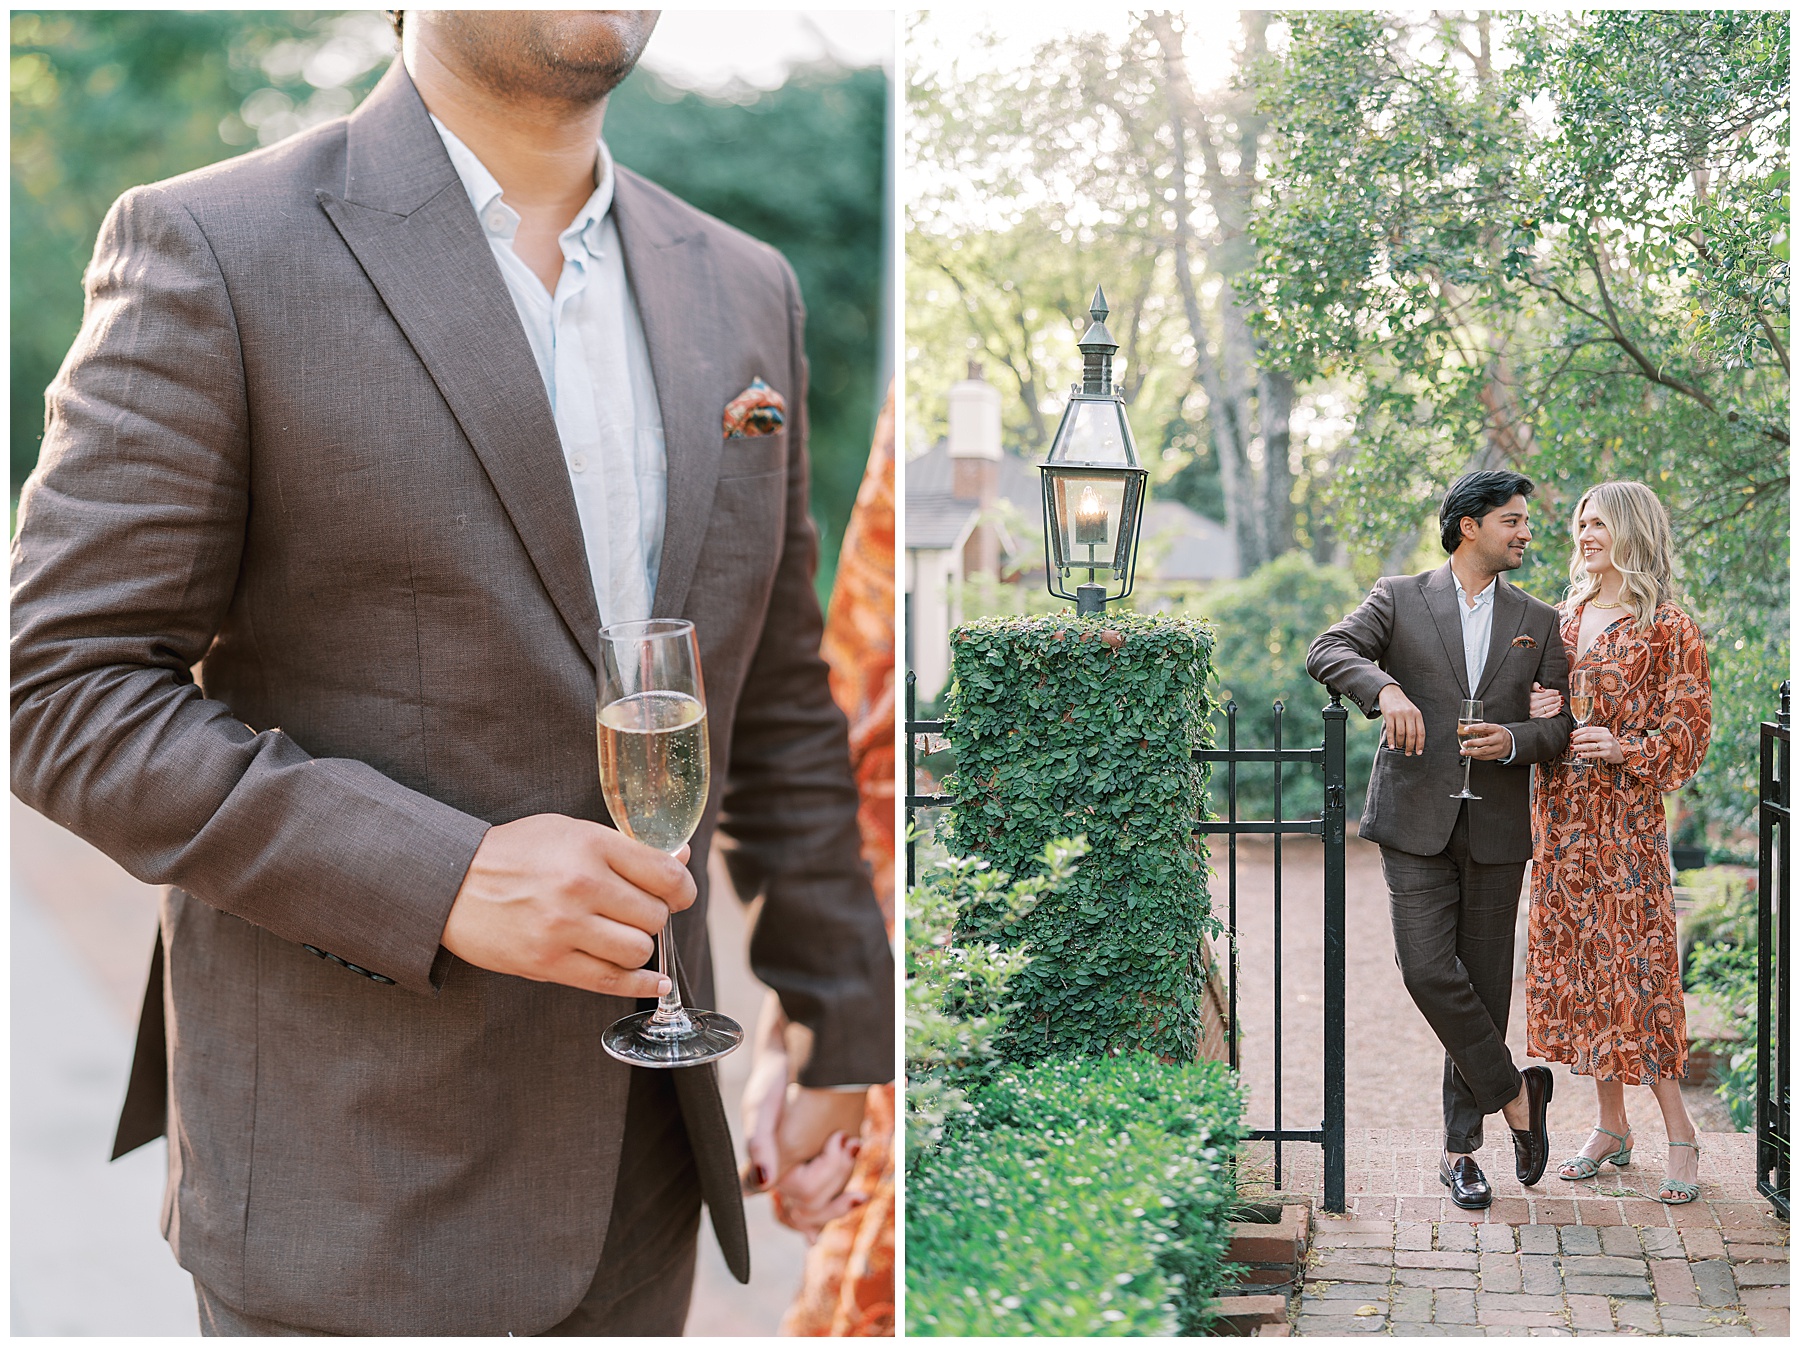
[432,117,668,623]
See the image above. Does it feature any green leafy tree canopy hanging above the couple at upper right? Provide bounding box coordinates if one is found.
[1242,11,1789,823]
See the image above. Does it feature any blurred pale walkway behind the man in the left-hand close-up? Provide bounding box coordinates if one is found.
[11,800,806,1336]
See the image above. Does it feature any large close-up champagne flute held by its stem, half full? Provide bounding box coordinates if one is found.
[596,618,743,1066]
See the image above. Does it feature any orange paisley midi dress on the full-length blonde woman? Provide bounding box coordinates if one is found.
[1525,603,1712,1086]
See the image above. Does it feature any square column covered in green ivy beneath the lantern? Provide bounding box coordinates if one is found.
[947,612,1217,1062]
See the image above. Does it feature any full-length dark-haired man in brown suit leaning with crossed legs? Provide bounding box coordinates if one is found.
[1307,472,1573,1208]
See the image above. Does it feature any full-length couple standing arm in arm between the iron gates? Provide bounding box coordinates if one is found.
[1307,472,1712,1208]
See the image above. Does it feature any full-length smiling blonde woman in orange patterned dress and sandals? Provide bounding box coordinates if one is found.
[1526,481,1712,1205]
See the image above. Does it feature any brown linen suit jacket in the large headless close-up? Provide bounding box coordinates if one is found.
[13,61,893,1334]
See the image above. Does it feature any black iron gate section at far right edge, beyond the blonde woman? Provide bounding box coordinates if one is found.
[1757,683,1791,1217]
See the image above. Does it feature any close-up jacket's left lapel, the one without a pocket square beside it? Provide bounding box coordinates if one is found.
[319,61,599,661]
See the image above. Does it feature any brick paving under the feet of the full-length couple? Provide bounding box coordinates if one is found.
[1294,1129,1787,1338]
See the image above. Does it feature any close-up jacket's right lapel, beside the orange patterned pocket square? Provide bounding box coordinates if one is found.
[612,166,736,618]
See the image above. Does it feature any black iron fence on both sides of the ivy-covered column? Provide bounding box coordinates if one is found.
[905,672,1353,1212]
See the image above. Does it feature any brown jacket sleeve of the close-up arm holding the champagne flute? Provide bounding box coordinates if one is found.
[11,187,486,992]
